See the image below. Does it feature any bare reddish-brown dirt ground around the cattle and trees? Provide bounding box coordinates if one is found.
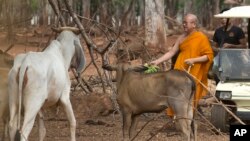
[0,28,229,141]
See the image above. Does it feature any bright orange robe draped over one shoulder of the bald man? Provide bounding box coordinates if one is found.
[167,31,214,116]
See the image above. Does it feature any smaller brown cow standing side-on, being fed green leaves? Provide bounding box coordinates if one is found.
[103,64,195,141]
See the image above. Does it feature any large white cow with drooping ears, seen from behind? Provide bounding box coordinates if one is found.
[8,27,85,141]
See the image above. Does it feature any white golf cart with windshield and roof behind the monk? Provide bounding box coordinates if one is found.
[211,6,250,132]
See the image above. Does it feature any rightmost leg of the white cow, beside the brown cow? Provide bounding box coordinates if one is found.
[60,87,76,141]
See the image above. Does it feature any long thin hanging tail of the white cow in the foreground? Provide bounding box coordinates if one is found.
[15,65,28,141]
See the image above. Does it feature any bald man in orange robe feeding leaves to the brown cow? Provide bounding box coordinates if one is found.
[151,14,214,117]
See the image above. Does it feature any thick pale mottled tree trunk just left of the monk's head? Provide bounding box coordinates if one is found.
[145,0,166,52]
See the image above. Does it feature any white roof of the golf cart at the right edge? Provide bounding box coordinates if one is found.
[214,6,250,18]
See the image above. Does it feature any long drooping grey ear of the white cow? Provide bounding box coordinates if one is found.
[73,39,86,73]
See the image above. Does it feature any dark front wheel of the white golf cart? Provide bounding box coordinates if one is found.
[211,105,229,132]
